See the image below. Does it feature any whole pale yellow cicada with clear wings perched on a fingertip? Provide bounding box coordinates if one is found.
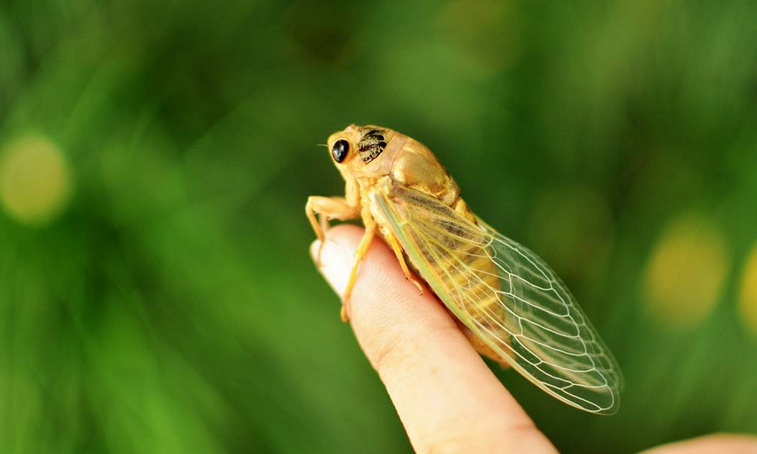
[305,125,622,414]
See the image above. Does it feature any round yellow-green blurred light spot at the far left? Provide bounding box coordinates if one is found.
[0,134,71,225]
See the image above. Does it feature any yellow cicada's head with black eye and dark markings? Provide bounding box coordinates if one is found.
[328,125,404,178]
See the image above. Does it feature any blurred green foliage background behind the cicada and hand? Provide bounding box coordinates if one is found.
[0,0,757,453]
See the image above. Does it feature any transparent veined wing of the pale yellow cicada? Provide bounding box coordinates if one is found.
[372,183,623,414]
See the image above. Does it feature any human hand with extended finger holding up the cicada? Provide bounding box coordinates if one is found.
[311,225,757,454]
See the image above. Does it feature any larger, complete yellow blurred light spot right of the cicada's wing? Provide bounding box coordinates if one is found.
[644,214,729,328]
